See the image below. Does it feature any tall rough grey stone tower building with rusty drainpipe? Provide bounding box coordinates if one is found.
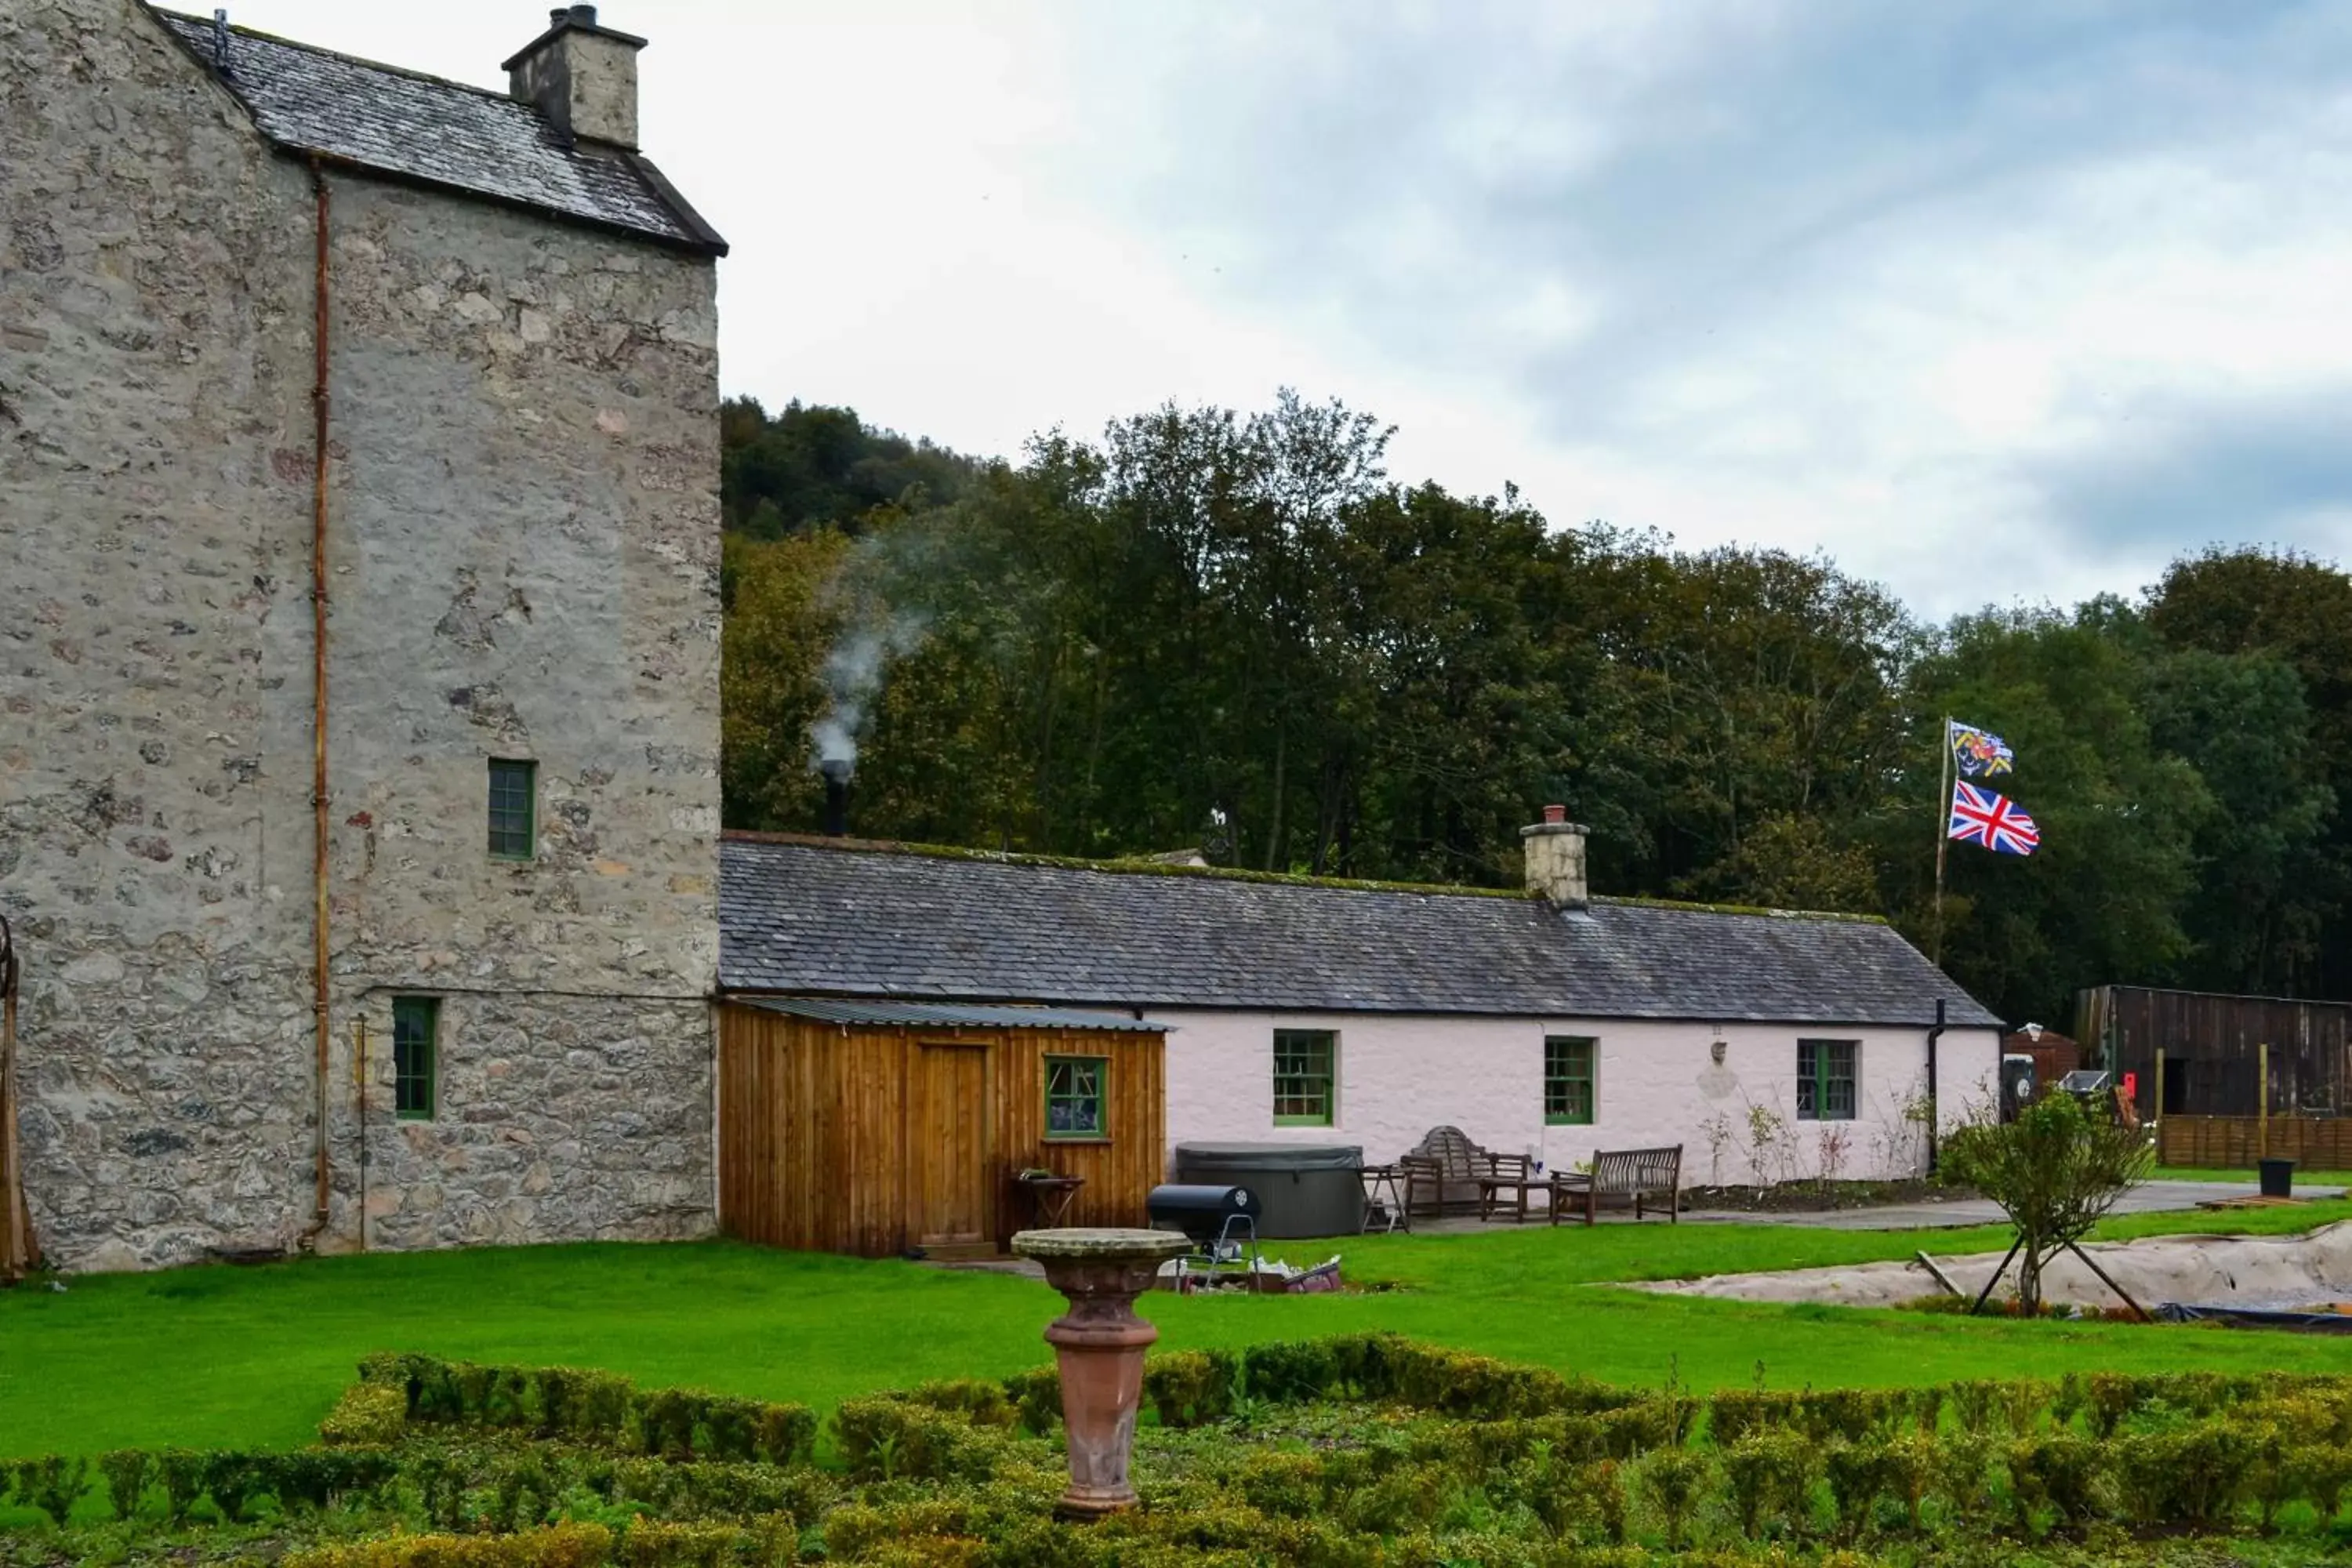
[0,0,724,1267]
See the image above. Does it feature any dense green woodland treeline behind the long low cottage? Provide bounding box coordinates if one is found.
[724,395,2352,1027]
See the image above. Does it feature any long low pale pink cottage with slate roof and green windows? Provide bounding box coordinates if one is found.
[720,806,2002,1182]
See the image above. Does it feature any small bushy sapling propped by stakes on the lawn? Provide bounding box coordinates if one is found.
[1943,1093,2154,1314]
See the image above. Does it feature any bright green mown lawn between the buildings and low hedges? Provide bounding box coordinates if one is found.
[13,1201,2352,1455]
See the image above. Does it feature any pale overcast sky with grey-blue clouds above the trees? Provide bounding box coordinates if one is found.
[216,0,2352,614]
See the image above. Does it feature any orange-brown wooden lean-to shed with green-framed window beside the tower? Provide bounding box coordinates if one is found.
[720,994,1167,1258]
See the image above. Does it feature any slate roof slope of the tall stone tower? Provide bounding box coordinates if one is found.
[148,7,727,256]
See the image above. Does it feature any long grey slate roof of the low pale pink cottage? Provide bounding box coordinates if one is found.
[720,837,1999,1027]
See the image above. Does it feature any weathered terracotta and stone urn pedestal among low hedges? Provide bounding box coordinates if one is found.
[1014,1229,1192,1519]
